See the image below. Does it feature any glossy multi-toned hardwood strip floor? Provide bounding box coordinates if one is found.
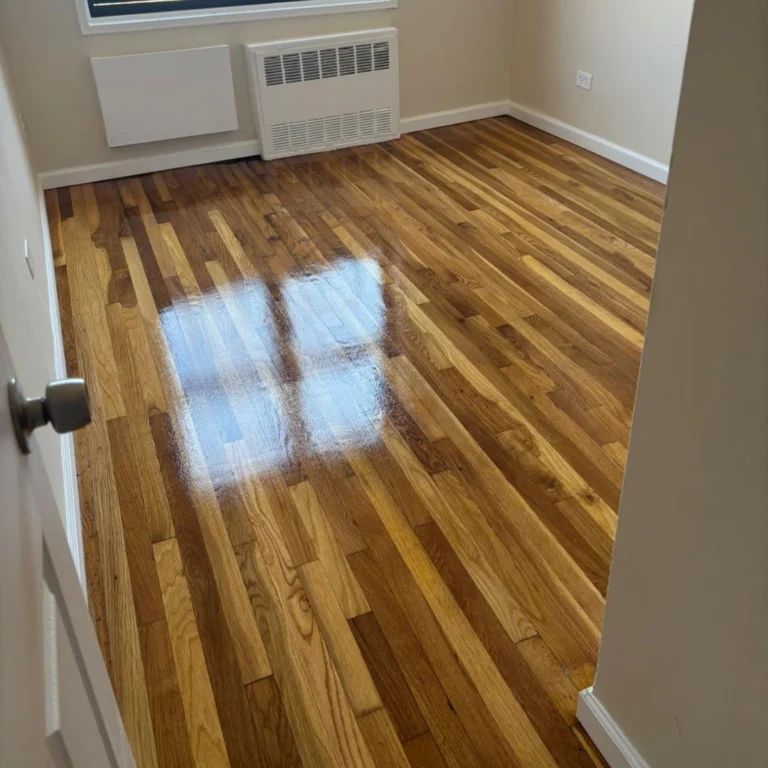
[47,118,664,768]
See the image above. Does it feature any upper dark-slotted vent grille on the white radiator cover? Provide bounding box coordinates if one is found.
[264,41,390,86]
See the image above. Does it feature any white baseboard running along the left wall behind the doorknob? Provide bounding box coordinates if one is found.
[37,179,88,588]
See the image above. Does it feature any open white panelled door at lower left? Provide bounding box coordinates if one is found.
[0,326,134,768]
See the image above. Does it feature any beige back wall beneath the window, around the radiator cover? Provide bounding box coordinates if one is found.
[0,0,511,171]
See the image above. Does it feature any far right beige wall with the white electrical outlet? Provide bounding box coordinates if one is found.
[510,0,693,164]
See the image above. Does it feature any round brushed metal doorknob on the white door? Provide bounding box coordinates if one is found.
[8,379,91,453]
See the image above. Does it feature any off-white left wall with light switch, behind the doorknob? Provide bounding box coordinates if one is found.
[0,46,64,514]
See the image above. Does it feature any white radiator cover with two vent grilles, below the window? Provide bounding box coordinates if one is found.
[246,28,400,160]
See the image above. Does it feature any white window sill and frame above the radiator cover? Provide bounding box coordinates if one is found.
[75,0,398,35]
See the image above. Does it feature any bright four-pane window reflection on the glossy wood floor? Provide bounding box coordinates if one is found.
[161,257,388,486]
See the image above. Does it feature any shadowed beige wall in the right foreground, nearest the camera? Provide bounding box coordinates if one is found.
[594,0,768,768]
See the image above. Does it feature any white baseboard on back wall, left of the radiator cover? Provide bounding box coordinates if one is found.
[40,139,260,189]
